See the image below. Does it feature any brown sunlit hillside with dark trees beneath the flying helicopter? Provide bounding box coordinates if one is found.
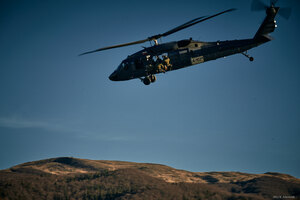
[0,157,300,200]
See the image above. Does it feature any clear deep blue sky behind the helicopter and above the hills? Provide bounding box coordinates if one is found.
[0,0,300,178]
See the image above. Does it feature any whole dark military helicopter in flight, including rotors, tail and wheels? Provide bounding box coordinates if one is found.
[80,0,291,85]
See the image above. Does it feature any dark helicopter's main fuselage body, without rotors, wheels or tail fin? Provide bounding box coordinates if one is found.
[109,39,267,81]
